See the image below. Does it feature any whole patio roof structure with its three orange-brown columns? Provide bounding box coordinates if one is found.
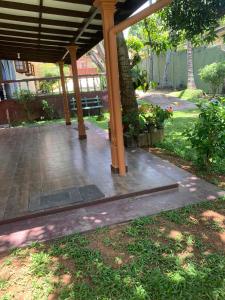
[0,0,172,175]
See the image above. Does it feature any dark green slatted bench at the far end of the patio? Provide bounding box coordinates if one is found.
[70,96,103,116]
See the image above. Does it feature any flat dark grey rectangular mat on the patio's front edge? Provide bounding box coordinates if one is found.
[29,185,105,211]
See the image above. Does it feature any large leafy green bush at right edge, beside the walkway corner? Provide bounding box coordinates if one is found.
[185,99,225,169]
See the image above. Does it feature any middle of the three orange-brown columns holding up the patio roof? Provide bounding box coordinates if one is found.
[66,45,87,140]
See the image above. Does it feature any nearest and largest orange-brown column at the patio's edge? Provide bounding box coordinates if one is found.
[94,0,126,176]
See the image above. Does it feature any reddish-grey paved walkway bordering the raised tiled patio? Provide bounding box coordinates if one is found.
[0,123,225,252]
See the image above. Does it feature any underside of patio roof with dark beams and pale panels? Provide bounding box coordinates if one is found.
[0,0,146,63]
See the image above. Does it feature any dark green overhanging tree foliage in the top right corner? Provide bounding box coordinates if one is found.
[162,0,225,44]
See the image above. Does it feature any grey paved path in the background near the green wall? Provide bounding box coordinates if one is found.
[140,92,197,111]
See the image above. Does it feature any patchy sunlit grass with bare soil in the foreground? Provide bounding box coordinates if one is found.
[0,199,225,300]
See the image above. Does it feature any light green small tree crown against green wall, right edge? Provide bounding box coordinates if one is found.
[199,62,225,95]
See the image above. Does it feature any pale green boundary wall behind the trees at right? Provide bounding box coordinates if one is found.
[140,46,225,93]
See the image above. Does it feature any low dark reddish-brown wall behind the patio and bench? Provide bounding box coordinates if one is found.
[0,91,108,125]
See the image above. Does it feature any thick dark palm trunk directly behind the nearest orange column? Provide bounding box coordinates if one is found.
[117,33,138,115]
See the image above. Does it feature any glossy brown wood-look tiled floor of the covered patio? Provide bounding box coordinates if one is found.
[0,124,177,220]
